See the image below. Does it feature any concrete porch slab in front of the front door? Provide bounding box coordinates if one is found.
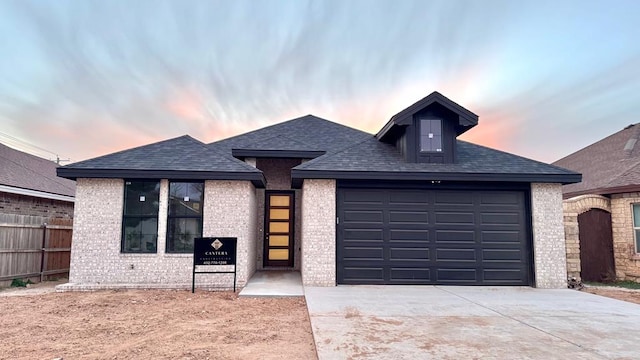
[238,271,304,297]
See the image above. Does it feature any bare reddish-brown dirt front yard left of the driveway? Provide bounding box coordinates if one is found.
[0,284,317,359]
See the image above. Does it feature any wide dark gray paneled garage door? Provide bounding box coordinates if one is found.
[337,188,531,285]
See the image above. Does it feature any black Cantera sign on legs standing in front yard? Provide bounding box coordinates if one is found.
[191,237,238,293]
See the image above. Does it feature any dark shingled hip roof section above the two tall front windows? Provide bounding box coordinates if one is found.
[58,135,264,186]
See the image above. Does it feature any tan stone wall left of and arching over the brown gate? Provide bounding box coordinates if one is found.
[562,195,611,280]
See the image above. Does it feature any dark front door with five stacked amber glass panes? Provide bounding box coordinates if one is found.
[264,191,294,267]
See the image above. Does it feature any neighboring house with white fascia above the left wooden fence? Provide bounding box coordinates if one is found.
[0,144,76,218]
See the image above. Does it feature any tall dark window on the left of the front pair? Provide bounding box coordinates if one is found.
[121,181,160,253]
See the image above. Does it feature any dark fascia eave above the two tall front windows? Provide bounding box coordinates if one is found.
[57,167,266,188]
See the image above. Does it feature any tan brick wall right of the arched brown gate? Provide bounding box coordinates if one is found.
[611,192,640,282]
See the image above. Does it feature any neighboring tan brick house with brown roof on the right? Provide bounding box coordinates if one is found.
[554,124,640,281]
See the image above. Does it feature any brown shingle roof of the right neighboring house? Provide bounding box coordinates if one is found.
[554,124,640,197]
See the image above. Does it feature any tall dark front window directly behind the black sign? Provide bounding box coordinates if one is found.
[167,182,204,253]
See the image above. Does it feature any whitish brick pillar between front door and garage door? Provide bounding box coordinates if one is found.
[301,179,336,286]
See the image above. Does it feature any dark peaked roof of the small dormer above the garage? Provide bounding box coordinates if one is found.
[376,91,478,142]
